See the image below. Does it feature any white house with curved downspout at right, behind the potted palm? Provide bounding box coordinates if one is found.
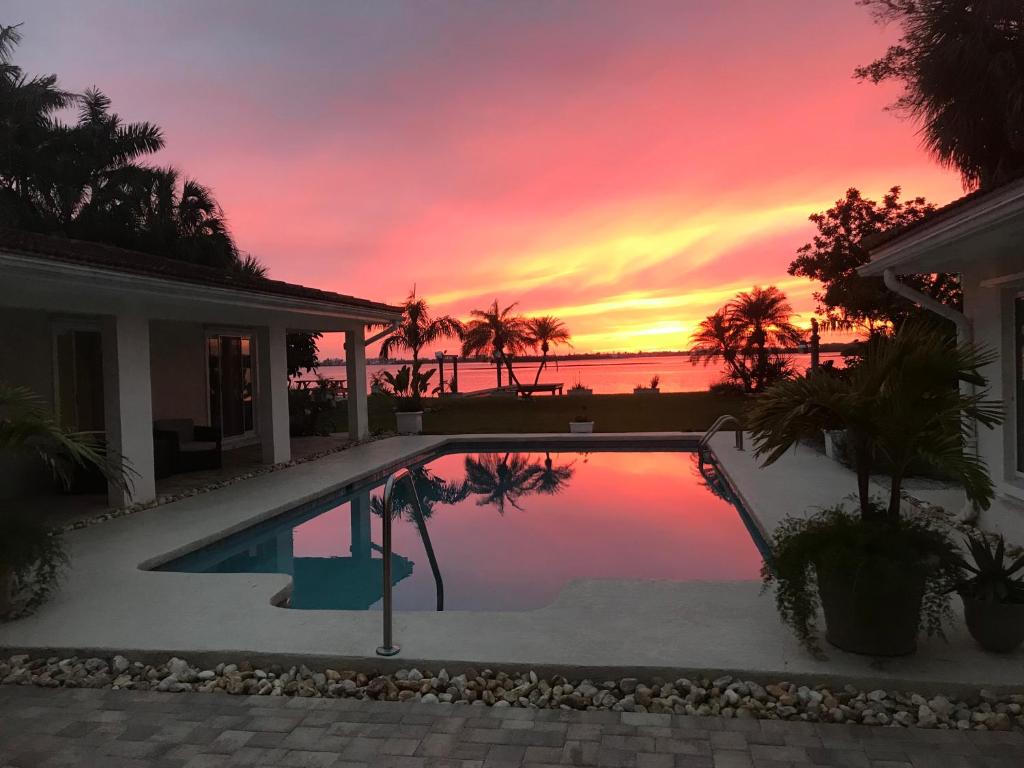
[860,179,1024,543]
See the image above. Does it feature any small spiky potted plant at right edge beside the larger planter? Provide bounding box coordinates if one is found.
[956,534,1024,653]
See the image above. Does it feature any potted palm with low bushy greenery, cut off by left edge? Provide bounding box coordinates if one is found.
[0,382,131,617]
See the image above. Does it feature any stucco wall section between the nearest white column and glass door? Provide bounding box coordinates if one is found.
[150,322,210,425]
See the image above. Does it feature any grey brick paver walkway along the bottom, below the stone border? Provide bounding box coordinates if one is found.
[0,686,1024,768]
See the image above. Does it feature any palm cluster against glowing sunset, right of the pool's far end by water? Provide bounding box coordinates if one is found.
[690,286,804,392]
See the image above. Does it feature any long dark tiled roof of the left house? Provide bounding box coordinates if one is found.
[0,227,401,314]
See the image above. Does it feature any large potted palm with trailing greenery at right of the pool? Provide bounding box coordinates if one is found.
[748,324,1002,655]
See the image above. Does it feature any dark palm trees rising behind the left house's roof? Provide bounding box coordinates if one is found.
[0,26,265,279]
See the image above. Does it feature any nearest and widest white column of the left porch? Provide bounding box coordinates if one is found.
[103,313,157,507]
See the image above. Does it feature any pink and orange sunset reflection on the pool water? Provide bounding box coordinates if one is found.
[293,452,761,610]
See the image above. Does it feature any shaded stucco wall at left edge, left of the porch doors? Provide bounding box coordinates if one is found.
[0,307,53,499]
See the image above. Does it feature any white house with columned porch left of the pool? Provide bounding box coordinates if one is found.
[0,228,401,506]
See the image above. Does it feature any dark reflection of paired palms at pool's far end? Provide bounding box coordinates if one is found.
[465,454,572,514]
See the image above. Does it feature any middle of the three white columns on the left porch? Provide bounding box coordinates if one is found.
[256,326,292,464]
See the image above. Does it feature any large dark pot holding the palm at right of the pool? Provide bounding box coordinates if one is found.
[817,564,927,656]
